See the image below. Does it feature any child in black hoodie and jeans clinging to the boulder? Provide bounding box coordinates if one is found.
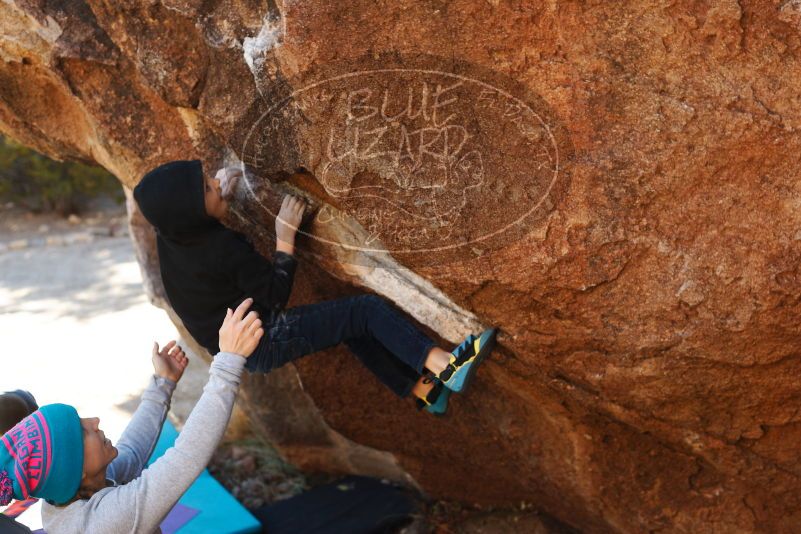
[134,160,495,415]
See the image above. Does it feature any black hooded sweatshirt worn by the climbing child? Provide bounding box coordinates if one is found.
[134,160,297,354]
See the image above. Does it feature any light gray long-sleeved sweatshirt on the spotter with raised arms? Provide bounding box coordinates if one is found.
[42,352,245,534]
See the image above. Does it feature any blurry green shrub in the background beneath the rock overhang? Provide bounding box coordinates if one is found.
[0,136,124,216]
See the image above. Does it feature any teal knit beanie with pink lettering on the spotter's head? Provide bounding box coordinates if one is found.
[0,404,83,506]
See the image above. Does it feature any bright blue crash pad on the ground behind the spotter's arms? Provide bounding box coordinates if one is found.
[147,421,261,534]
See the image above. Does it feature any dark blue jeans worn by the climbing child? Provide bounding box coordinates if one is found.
[245,294,436,397]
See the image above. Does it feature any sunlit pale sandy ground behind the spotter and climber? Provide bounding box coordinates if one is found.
[0,207,208,527]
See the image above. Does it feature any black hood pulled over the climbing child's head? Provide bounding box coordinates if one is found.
[133,160,219,240]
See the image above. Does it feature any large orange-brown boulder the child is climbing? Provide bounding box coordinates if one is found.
[0,0,801,532]
